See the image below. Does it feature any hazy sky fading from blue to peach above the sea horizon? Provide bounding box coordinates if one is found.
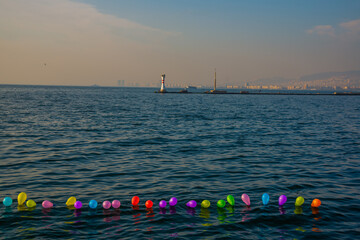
[0,0,360,86]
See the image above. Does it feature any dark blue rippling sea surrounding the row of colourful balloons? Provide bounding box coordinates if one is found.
[0,85,360,239]
